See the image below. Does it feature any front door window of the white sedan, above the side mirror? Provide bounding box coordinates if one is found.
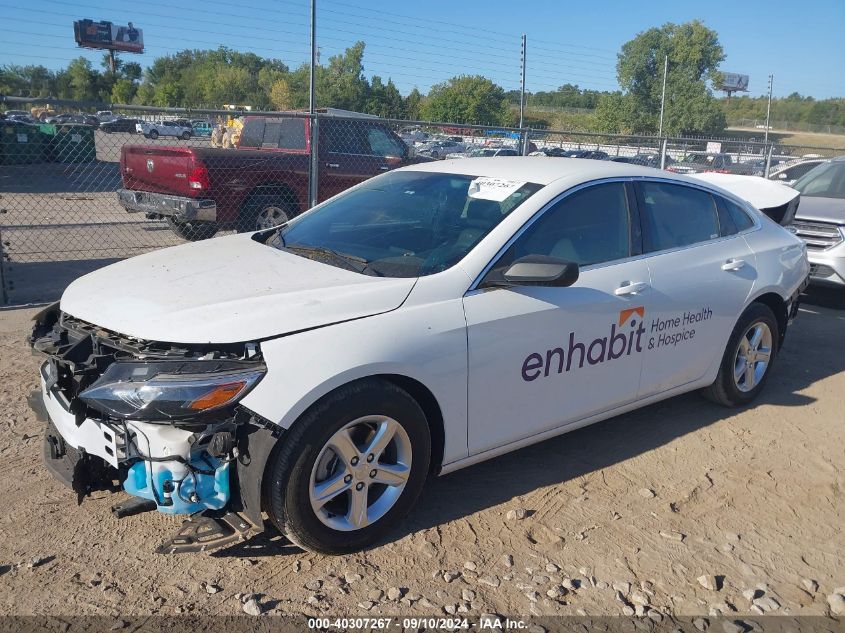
[503,182,631,266]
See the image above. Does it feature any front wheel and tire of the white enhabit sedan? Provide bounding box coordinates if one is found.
[264,378,431,555]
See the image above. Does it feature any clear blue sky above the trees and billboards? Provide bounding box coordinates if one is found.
[0,0,845,99]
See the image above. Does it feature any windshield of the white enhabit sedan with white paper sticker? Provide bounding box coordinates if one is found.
[266,171,542,277]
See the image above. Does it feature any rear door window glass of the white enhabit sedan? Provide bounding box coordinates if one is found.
[639,181,720,253]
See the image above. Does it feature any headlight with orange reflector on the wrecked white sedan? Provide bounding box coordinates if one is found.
[79,360,267,420]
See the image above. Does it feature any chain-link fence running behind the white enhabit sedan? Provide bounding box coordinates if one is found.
[0,98,836,305]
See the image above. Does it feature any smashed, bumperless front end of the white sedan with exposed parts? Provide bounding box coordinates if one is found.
[30,304,278,552]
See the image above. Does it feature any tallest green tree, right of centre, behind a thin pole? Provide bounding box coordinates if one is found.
[596,20,726,134]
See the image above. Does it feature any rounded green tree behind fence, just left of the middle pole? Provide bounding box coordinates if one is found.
[422,75,510,125]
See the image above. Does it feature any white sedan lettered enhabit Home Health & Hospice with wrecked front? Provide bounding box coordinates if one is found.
[32,157,809,554]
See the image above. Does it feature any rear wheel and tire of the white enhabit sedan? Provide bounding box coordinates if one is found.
[703,303,780,407]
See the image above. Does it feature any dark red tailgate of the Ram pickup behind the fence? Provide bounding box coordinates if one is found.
[120,145,203,197]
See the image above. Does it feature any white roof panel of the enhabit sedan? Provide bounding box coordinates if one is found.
[402,156,701,186]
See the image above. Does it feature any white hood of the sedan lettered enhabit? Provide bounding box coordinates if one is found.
[61,235,416,344]
